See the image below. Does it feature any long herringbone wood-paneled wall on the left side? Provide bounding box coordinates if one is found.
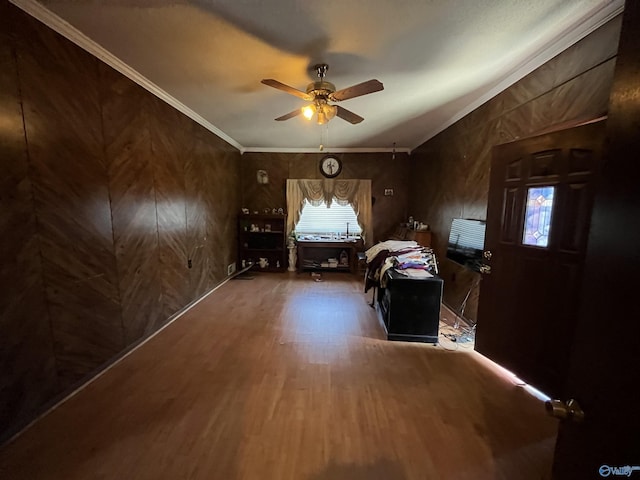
[0,0,240,440]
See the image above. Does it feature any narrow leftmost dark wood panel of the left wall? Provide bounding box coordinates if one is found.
[0,3,60,442]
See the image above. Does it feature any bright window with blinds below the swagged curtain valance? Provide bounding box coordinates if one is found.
[296,200,362,235]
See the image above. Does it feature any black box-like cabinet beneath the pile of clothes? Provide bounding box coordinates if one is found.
[376,269,444,343]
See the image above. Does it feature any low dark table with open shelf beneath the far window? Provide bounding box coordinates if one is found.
[296,240,361,273]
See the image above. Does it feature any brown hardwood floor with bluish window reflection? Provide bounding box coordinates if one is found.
[0,273,557,480]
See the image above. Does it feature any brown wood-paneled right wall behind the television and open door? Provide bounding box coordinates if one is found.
[410,18,620,321]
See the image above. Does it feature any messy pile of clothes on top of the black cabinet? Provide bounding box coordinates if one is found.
[364,240,438,292]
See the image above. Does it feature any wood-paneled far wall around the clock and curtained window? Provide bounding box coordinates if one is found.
[241,153,411,242]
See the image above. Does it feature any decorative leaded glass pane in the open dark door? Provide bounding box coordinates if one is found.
[522,187,556,247]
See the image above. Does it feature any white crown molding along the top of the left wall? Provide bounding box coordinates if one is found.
[9,0,244,153]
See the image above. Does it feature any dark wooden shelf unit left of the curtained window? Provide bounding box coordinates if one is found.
[238,214,287,272]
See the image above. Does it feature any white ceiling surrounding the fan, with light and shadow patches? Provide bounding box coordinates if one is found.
[12,0,624,152]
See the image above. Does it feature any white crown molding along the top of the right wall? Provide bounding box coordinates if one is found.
[411,0,624,150]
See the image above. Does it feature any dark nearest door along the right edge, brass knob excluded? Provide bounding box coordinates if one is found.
[553,2,640,480]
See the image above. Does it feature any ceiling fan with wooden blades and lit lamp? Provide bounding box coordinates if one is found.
[261,63,384,125]
